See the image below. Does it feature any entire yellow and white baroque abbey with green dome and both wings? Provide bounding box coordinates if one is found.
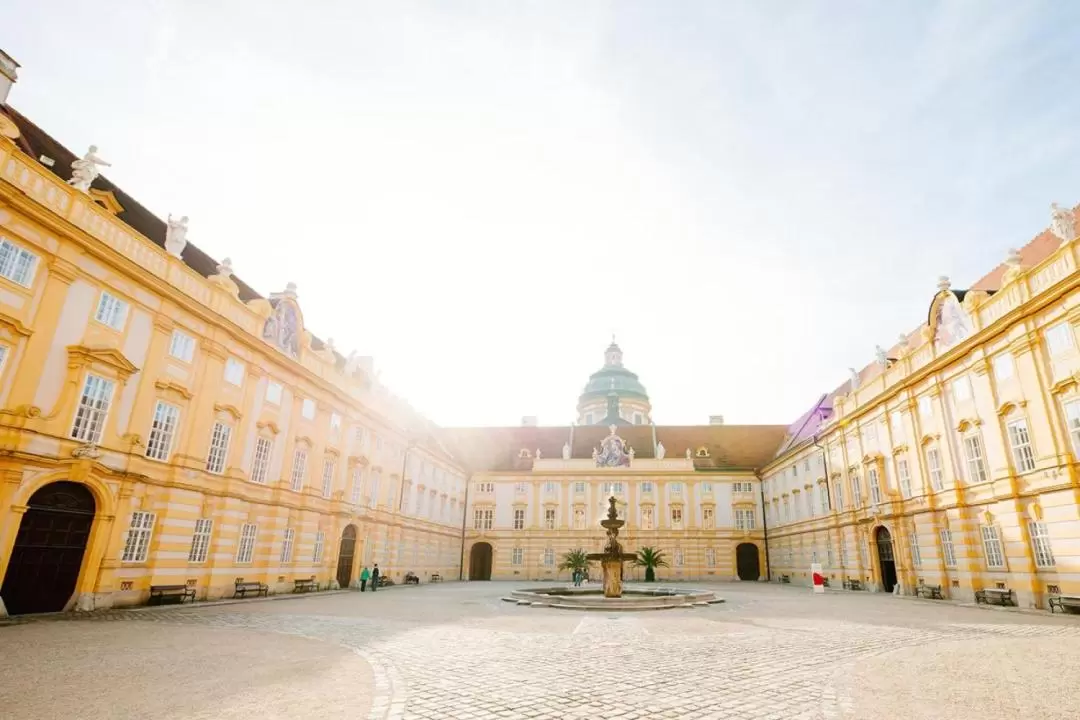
[0,53,1080,613]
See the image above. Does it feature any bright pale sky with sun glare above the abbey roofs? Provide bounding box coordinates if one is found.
[0,0,1080,425]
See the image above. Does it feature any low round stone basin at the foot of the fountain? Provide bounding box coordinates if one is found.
[503,585,724,611]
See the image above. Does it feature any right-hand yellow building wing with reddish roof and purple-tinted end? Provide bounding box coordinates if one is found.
[761,208,1080,608]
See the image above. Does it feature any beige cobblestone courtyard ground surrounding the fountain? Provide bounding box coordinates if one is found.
[0,583,1080,720]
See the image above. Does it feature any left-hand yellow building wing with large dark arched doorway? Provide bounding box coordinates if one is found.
[0,95,465,613]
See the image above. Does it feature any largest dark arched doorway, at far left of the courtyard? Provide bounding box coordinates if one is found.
[0,480,97,615]
